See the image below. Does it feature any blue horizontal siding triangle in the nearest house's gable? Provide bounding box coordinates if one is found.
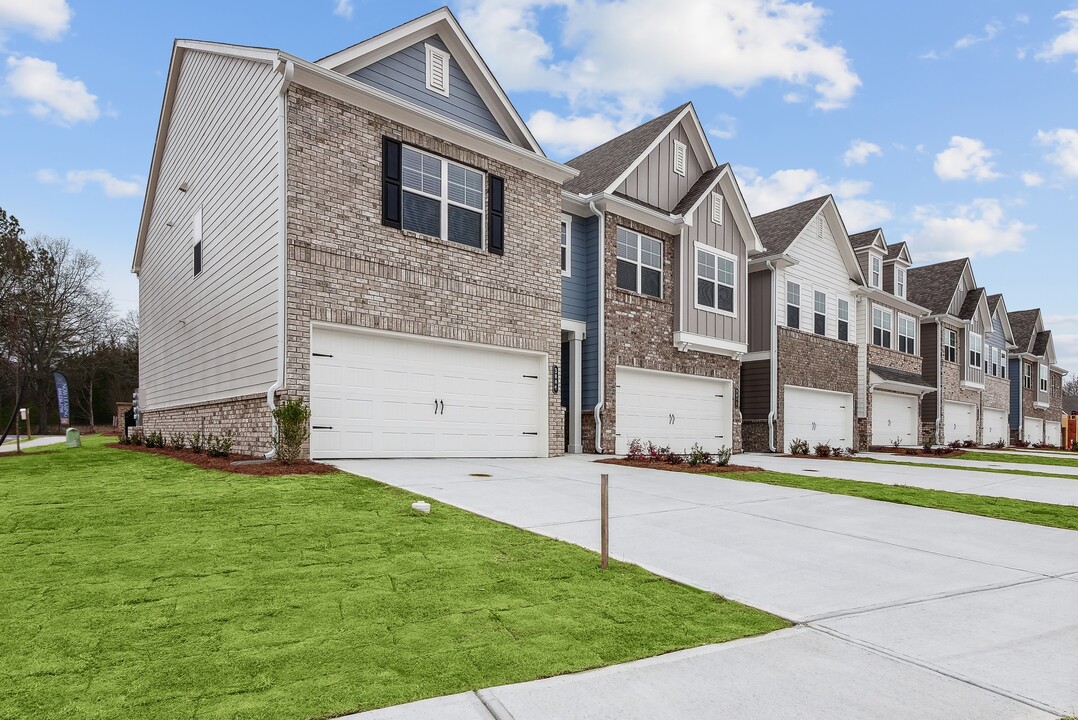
[350,36,509,140]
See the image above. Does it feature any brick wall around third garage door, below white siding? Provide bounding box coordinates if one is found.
[764,328,858,453]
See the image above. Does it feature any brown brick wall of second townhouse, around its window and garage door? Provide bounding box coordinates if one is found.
[599,212,742,453]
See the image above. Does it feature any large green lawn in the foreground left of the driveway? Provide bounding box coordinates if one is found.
[0,438,787,719]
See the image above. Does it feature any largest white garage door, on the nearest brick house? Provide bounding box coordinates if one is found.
[310,328,548,458]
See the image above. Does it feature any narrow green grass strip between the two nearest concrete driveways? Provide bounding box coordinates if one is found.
[714,472,1078,530]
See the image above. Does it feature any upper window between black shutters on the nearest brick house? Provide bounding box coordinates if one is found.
[401,146,485,248]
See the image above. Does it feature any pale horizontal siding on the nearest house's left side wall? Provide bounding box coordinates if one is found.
[139,51,280,410]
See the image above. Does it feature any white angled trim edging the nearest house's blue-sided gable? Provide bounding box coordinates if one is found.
[316,8,543,155]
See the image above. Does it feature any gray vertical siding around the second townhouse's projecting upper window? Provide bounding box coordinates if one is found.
[675,188,748,343]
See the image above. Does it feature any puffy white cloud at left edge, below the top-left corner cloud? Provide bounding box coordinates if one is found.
[8,57,100,125]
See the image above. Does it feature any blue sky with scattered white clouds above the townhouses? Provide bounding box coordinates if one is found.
[0,0,1078,370]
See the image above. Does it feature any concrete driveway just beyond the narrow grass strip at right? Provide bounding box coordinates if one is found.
[737,453,1078,506]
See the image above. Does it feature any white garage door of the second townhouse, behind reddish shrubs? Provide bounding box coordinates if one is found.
[616,368,733,455]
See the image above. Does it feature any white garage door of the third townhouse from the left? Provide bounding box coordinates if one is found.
[782,385,854,453]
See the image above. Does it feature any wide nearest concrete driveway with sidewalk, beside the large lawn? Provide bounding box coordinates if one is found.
[337,457,1078,720]
